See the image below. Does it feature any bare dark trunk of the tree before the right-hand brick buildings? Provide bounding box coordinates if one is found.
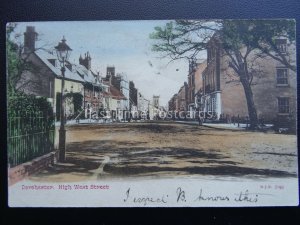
[240,76,258,130]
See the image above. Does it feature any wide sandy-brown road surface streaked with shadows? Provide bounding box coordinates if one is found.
[30,123,297,182]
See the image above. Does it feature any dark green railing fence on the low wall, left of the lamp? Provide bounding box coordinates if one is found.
[8,115,55,167]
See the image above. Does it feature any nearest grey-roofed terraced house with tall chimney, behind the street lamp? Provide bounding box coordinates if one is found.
[17,26,105,120]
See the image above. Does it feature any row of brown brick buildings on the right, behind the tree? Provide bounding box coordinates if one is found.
[168,32,297,125]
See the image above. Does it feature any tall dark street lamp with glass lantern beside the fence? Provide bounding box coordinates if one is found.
[55,37,72,162]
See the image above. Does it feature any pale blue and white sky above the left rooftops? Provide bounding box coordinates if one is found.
[15,20,207,106]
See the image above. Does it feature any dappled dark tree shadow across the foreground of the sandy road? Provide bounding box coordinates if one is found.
[36,140,296,180]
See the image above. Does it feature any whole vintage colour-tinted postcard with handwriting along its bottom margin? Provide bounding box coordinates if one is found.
[6,19,299,207]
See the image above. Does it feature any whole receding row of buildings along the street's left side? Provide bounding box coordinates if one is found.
[17,26,159,121]
